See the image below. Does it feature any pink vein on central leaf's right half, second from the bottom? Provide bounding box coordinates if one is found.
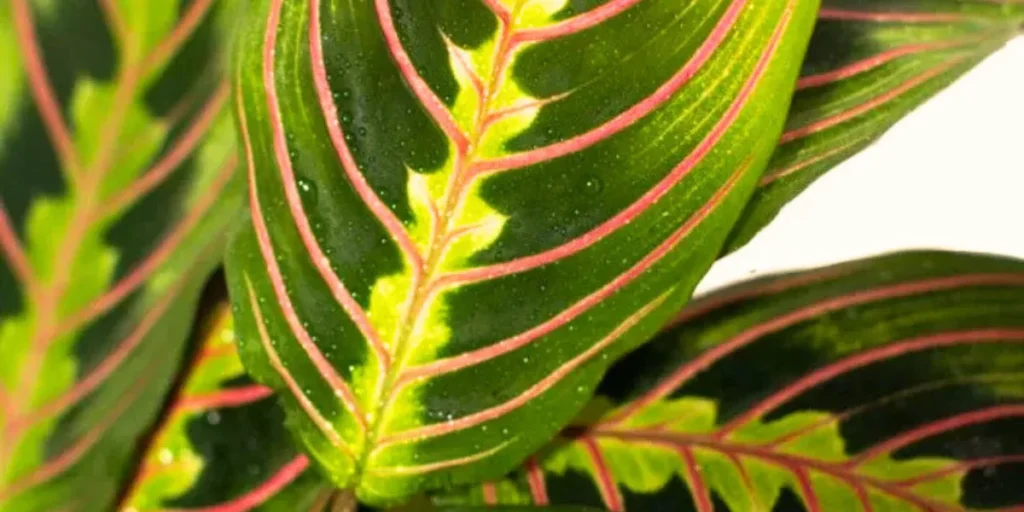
[378,290,672,446]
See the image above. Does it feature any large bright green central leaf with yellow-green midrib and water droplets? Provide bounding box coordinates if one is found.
[227,0,817,504]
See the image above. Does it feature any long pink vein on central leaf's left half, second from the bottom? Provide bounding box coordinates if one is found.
[237,49,366,427]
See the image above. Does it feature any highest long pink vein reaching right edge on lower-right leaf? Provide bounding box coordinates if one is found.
[609,273,1024,423]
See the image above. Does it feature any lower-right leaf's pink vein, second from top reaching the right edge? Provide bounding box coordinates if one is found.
[716,329,1024,438]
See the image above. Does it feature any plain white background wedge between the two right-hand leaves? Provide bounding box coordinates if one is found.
[697,38,1024,293]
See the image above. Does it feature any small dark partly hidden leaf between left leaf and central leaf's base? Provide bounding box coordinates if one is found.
[118,301,333,512]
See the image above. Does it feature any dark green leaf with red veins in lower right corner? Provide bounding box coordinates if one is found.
[441,252,1024,512]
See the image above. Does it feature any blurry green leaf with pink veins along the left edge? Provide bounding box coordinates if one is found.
[0,0,244,512]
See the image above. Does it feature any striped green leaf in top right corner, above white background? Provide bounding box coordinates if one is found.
[726,0,1024,252]
